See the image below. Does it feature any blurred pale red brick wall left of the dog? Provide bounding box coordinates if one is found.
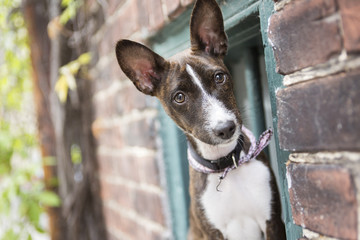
[86,0,193,240]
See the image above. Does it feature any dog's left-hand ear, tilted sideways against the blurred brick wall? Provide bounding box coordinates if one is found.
[116,40,168,96]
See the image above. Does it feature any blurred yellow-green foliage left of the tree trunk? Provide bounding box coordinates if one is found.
[0,0,60,240]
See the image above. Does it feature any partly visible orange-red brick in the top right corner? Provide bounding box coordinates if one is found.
[338,0,360,53]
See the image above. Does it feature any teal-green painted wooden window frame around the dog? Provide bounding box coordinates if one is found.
[149,0,302,240]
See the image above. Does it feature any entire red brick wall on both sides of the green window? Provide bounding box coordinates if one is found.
[86,0,360,240]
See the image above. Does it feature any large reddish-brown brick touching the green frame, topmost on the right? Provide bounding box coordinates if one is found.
[268,0,342,74]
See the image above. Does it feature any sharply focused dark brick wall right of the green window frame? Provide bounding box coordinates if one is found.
[268,0,360,239]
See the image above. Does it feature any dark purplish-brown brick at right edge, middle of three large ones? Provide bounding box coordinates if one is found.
[277,70,360,151]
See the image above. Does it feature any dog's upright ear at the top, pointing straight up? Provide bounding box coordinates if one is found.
[190,0,227,57]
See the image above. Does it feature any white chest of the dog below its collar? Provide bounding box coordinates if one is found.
[201,160,271,240]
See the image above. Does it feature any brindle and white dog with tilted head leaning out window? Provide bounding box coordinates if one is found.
[116,0,286,240]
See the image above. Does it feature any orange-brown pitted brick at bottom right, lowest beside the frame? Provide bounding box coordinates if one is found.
[287,163,357,240]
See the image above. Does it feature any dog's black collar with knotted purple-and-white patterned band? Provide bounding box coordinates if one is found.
[188,125,273,190]
